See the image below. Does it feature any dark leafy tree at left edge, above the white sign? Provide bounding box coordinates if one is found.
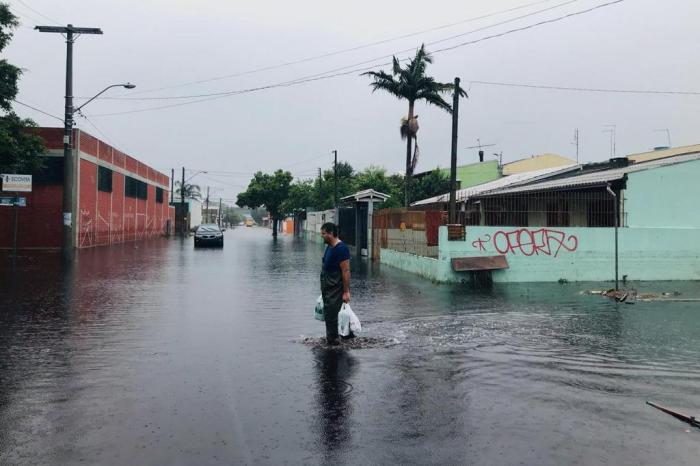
[0,3,46,173]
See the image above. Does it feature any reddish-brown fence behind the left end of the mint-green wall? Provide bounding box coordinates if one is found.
[372,209,446,259]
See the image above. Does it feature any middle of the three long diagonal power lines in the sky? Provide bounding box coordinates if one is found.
[86,0,580,101]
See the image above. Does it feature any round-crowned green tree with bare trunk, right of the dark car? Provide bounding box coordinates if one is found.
[236,170,292,237]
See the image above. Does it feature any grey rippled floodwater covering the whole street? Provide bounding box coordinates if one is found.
[0,228,700,465]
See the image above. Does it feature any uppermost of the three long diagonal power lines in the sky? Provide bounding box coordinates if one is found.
[117,0,552,95]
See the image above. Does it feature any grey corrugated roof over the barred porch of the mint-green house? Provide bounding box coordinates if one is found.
[482,152,700,196]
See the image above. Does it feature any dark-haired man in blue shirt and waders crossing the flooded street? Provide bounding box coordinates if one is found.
[321,222,352,345]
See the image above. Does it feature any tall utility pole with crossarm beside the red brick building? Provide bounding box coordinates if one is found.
[34,24,102,259]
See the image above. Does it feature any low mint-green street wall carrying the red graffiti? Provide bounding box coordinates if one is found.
[381,227,700,282]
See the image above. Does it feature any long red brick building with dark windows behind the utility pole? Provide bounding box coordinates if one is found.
[0,128,175,249]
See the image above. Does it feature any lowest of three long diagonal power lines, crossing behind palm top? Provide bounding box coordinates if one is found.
[87,0,624,117]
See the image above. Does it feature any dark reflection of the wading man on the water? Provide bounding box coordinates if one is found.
[313,347,357,464]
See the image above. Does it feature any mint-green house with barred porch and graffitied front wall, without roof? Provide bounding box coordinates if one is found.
[381,152,700,282]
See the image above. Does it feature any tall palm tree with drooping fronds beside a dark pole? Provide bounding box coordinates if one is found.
[362,44,467,207]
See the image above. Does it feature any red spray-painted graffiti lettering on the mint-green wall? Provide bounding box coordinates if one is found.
[472,228,578,257]
